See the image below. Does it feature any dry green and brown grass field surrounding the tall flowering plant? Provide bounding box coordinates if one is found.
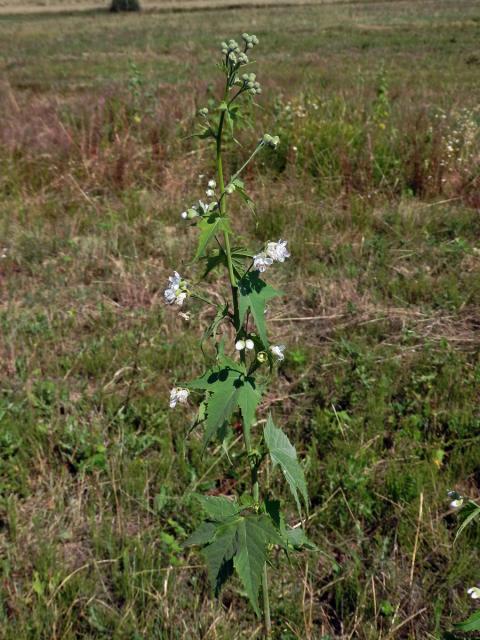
[0,0,480,640]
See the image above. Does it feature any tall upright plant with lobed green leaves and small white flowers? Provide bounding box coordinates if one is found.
[165,33,312,635]
